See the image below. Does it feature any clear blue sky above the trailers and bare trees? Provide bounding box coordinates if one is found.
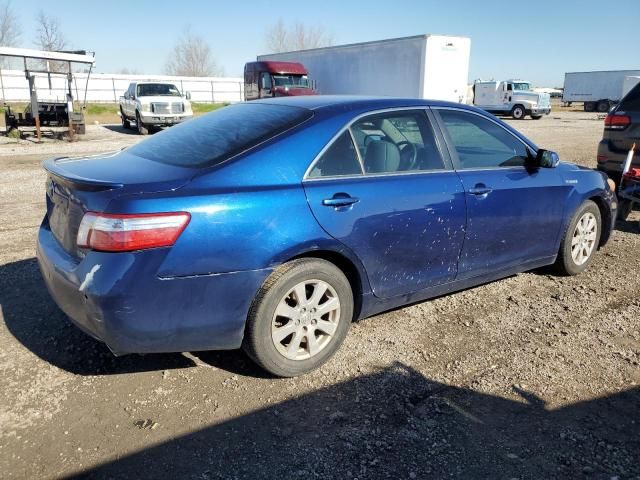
[12,0,640,86]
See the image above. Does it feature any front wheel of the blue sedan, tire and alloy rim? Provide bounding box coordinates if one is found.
[555,200,602,276]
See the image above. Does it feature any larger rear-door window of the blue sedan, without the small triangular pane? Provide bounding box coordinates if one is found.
[351,110,445,174]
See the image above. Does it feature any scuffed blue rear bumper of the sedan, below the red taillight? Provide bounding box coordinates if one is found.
[37,220,271,355]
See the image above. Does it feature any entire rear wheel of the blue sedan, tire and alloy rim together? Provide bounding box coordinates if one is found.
[242,258,353,377]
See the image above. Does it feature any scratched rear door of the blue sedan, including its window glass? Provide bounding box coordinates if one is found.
[304,109,466,298]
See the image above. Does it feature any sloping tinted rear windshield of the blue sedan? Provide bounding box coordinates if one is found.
[128,103,313,168]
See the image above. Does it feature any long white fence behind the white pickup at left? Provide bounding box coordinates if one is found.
[0,70,244,103]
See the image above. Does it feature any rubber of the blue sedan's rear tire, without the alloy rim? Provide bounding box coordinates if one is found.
[242,258,353,377]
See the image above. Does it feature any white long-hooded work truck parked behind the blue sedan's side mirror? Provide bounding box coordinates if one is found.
[473,80,551,120]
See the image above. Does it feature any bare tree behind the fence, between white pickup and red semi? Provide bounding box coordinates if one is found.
[165,29,221,77]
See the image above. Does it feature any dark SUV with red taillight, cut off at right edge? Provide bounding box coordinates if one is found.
[598,83,640,183]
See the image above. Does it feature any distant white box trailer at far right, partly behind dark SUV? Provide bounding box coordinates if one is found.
[562,70,640,112]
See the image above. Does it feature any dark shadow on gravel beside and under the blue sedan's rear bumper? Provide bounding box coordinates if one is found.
[0,258,195,375]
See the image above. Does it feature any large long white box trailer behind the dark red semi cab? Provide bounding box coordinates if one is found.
[258,35,471,103]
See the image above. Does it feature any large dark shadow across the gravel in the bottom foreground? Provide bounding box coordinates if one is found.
[69,363,640,479]
